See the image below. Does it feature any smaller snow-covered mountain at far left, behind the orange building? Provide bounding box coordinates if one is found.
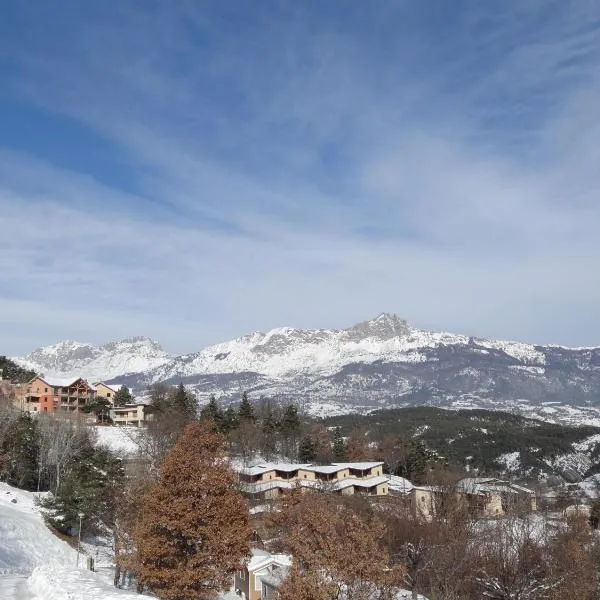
[15,337,172,381]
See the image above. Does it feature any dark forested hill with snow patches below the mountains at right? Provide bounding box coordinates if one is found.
[324,406,600,480]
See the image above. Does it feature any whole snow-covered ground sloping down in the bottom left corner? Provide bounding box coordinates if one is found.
[0,483,140,600]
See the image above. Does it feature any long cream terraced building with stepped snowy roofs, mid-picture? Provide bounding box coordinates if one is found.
[238,462,389,500]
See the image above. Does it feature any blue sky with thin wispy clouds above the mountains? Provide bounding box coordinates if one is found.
[0,0,600,355]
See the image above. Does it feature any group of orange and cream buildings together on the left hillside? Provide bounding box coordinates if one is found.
[6,376,147,426]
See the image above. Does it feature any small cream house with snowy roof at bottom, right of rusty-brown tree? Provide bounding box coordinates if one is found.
[234,548,292,600]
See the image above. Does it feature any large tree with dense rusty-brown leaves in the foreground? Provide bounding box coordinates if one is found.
[136,422,251,600]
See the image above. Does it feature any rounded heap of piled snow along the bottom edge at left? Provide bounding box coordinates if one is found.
[28,566,140,600]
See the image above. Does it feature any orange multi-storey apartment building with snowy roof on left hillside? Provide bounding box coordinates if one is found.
[15,376,96,414]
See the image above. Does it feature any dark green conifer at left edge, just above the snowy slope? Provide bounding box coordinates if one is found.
[0,413,38,490]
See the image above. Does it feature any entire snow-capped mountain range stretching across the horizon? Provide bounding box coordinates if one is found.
[14,313,600,425]
